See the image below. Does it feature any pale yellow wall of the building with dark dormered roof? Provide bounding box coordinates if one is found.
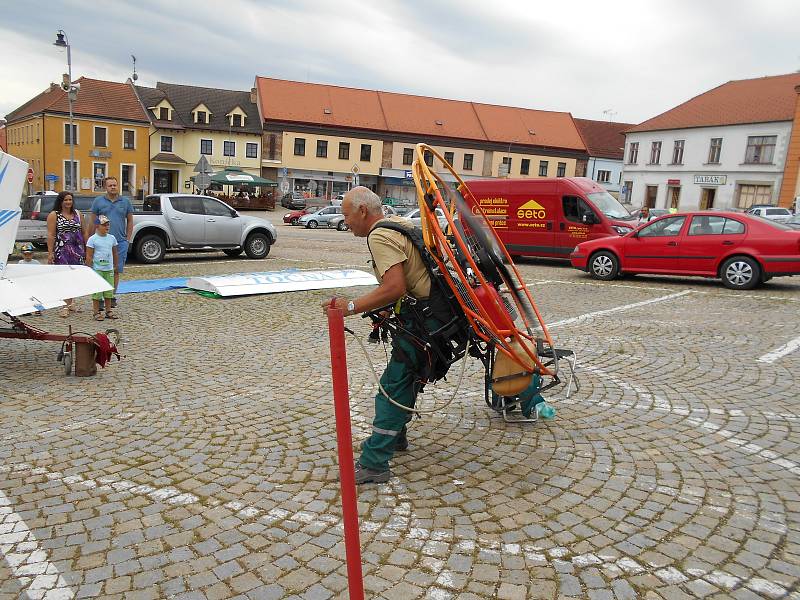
[150,127,261,192]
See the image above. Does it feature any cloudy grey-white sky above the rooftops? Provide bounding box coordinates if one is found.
[0,0,800,123]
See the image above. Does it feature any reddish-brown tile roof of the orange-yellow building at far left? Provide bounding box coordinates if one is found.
[6,77,148,123]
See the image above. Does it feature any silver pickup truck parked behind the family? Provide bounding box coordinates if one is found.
[130,194,277,263]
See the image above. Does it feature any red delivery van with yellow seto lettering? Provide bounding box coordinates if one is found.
[465,177,636,258]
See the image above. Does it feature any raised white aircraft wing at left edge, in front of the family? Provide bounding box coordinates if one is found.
[0,265,112,317]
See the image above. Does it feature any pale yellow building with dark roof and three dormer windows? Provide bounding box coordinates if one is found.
[134,82,261,193]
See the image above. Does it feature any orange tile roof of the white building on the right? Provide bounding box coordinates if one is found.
[628,73,800,132]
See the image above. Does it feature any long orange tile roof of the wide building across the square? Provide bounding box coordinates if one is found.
[256,77,586,151]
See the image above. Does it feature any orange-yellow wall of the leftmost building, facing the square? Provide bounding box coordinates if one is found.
[43,115,149,195]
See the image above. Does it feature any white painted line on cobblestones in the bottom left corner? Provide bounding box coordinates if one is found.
[0,490,75,600]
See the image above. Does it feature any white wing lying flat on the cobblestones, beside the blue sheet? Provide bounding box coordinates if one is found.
[186,269,378,296]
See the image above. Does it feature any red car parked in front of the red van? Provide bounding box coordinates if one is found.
[569,211,800,290]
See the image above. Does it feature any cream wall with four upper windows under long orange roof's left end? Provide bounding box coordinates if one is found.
[279,131,382,175]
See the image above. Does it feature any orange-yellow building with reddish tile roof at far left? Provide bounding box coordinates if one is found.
[6,77,149,197]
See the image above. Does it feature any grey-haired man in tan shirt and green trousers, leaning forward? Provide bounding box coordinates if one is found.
[322,186,441,484]
